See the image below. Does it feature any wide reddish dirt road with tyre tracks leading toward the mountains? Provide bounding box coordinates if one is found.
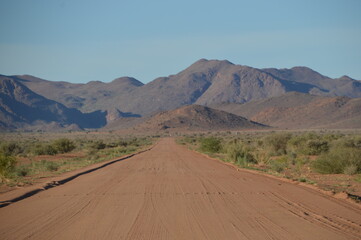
[0,139,361,240]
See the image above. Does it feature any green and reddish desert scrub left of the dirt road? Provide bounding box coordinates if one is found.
[0,133,154,186]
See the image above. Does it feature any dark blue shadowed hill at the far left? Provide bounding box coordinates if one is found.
[0,77,105,130]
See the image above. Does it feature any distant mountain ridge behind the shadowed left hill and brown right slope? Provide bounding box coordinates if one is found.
[11,59,361,119]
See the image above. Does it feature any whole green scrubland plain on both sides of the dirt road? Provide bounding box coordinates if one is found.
[0,130,361,200]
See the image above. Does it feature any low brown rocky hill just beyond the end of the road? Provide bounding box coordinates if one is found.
[135,105,266,131]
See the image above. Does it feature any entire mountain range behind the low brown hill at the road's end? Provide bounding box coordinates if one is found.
[0,59,361,129]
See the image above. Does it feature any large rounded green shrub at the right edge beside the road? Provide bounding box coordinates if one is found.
[312,147,361,174]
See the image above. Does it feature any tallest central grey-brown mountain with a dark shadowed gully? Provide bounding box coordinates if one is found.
[110,59,332,115]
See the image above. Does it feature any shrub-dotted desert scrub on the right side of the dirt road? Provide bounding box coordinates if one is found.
[178,131,361,194]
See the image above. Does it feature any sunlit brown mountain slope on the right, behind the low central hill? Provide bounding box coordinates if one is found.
[213,93,361,129]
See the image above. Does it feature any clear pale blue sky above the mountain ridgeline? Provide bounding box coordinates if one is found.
[0,0,361,83]
